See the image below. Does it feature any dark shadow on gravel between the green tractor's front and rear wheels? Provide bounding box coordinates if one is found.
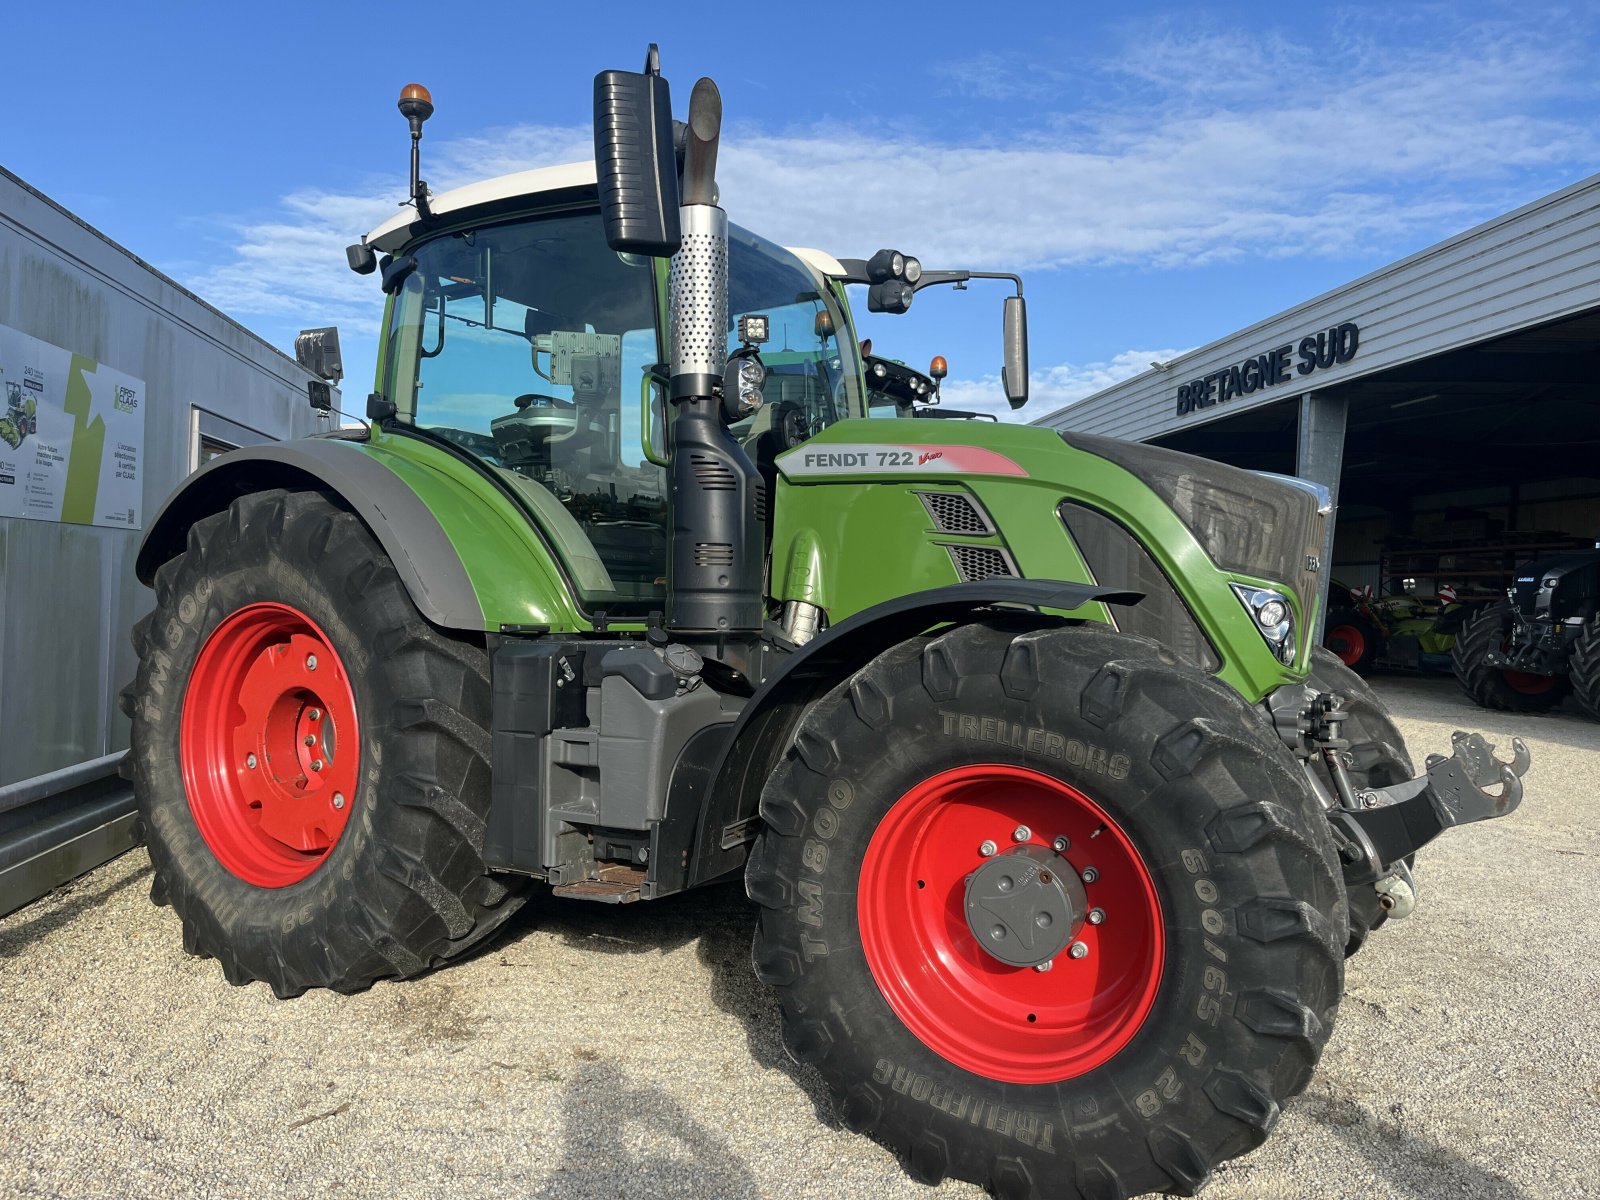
[483,880,842,1128]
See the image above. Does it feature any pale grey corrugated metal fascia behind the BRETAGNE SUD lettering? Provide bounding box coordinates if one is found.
[1035,176,1600,442]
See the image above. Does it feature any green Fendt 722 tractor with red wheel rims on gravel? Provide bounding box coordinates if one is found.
[125,54,1528,1197]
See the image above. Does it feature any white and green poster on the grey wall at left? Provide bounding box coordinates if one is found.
[0,325,144,530]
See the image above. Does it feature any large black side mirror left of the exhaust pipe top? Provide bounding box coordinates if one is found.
[595,43,683,258]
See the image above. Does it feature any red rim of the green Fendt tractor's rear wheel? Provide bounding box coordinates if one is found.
[178,603,362,888]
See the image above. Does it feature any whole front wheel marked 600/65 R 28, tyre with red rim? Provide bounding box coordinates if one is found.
[746,618,1347,1200]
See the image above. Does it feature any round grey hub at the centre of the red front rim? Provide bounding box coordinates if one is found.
[965,845,1088,966]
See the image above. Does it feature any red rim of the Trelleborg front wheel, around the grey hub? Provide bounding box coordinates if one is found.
[858,763,1165,1083]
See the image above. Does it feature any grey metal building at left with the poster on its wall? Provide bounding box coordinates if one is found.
[0,168,328,914]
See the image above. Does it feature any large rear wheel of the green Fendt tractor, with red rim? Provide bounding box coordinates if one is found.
[126,491,522,997]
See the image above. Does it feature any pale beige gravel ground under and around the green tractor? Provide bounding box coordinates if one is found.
[0,677,1600,1200]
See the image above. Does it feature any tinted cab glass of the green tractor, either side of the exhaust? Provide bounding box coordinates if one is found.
[384,213,864,616]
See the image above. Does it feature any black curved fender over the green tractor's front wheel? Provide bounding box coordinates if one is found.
[681,578,1144,886]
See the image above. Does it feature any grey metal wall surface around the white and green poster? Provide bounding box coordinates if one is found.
[0,170,317,786]
